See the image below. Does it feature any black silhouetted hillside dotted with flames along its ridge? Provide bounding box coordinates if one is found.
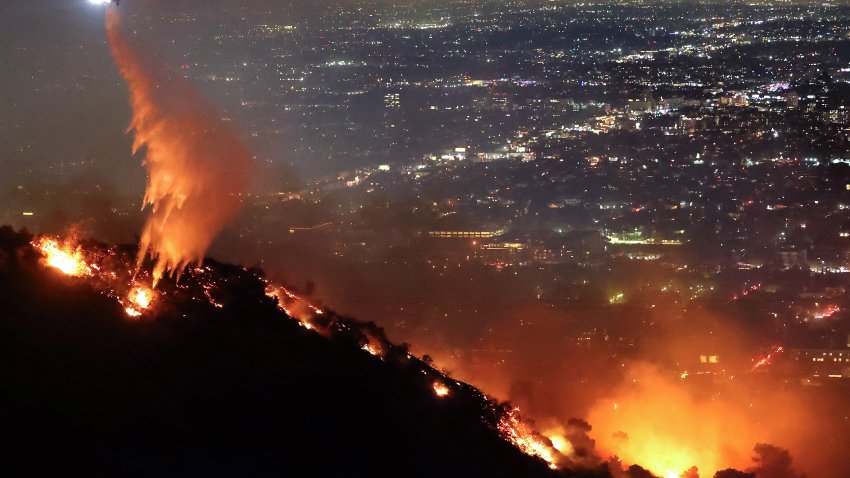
[0,228,607,476]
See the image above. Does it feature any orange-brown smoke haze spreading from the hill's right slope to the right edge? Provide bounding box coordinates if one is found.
[227,241,847,477]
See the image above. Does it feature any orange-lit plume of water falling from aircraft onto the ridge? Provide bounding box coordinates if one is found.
[106,9,251,283]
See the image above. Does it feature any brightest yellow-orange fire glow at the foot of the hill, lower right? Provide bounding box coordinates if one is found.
[588,364,767,478]
